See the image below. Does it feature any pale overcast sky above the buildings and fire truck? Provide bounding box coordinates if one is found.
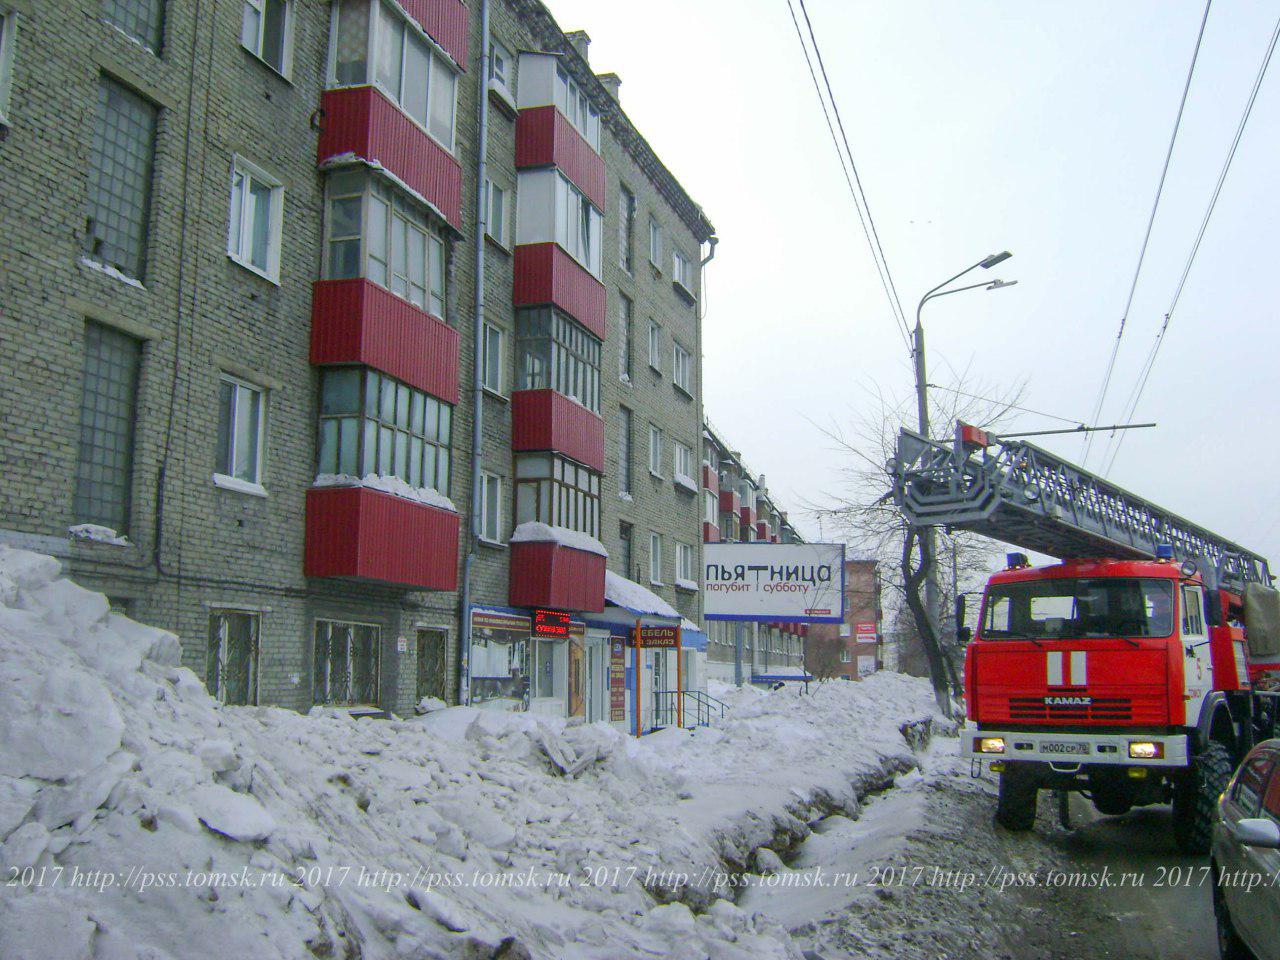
[549,0,1280,562]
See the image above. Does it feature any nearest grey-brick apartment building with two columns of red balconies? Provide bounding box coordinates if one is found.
[0,0,714,722]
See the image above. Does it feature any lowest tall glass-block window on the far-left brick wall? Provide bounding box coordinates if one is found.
[76,323,142,535]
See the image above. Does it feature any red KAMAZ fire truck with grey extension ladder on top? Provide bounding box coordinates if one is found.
[888,424,1280,852]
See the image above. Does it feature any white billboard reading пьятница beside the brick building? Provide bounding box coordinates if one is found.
[703,543,845,623]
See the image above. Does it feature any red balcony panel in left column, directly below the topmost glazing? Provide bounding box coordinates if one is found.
[317,87,462,229]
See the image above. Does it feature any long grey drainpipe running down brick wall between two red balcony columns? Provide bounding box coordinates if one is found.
[458,0,490,707]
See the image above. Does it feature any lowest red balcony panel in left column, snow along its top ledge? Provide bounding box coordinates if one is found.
[303,486,458,590]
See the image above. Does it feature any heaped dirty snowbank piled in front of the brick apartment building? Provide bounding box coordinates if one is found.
[0,548,933,960]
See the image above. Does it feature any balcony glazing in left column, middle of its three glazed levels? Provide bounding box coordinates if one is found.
[325,170,445,320]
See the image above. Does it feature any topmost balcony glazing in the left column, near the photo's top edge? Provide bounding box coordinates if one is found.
[330,0,457,152]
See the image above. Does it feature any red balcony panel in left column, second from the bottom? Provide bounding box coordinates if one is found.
[311,279,458,403]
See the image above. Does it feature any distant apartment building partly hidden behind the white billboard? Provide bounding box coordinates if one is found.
[700,420,808,684]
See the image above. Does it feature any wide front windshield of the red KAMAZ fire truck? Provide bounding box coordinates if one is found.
[982,577,1174,640]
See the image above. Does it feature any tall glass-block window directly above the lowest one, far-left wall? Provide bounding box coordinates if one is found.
[84,77,159,280]
